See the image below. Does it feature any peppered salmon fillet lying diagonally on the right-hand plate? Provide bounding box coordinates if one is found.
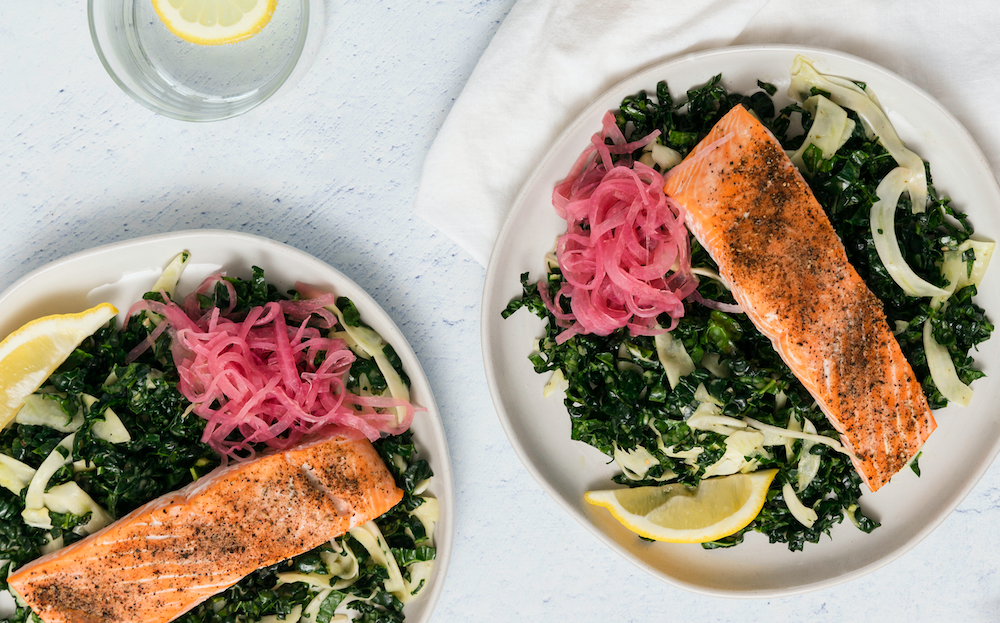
[664,106,937,491]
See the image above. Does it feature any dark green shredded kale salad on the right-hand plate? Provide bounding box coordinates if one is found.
[502,75,993,551]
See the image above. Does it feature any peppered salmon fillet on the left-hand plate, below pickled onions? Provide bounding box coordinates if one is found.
[8,438,403,623]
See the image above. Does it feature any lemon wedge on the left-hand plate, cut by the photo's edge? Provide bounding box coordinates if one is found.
[0,303,118,429]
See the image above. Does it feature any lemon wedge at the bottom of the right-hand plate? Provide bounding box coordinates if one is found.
[583,469,778,543]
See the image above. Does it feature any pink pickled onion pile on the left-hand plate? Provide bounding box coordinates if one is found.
[129,275,414,460]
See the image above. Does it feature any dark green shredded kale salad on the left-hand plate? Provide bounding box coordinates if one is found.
[0,267,437,623]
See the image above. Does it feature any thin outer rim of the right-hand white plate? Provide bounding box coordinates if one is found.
[480,44,1000,599]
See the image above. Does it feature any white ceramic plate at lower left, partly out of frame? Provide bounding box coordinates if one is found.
[0,230,455,623]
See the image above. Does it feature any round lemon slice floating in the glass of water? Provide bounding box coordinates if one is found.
[152,0,278,45]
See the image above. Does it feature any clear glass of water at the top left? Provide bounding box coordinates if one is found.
[88,0,325,121]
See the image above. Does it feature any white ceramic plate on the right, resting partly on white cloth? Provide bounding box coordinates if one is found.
[482,46,1000,597]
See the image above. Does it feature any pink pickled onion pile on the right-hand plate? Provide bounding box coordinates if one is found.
[538,112,698,344]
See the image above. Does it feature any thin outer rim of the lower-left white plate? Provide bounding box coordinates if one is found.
[0,229,456,623]
